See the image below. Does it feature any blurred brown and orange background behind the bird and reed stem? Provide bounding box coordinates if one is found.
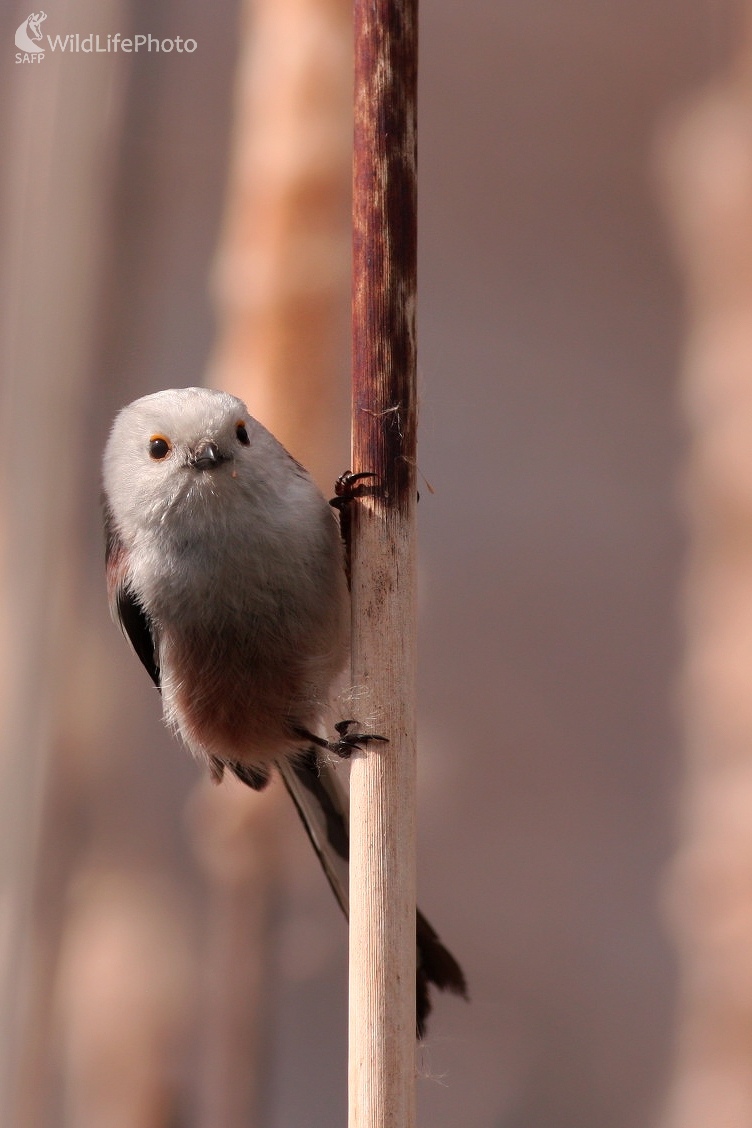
[0,0,752,1128]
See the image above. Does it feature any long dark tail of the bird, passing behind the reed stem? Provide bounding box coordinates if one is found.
[277,748,468,1038]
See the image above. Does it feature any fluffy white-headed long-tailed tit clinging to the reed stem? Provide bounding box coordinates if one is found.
[104,388,466,1032]
